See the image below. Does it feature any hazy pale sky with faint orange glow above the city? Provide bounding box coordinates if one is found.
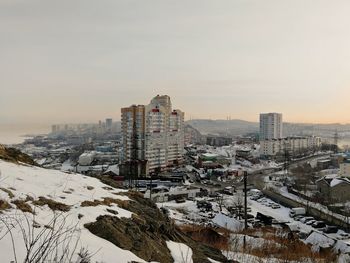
[0,0,350,124]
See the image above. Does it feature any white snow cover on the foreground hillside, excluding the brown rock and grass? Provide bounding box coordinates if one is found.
[0,160,197,263]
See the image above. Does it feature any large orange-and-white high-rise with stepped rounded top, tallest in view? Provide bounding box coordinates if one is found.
[121,95,184,176]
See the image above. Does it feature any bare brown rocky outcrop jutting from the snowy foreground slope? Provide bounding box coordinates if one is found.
[85,192,229,263]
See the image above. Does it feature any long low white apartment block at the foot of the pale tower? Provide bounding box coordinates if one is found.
[260,136,321,157]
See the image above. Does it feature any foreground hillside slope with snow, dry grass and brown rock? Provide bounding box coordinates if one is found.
[0,160,228,263]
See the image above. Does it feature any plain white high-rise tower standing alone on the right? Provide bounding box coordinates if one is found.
[259,113,283,140]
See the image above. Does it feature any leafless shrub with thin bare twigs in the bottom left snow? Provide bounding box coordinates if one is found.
[0,212,92,263]
